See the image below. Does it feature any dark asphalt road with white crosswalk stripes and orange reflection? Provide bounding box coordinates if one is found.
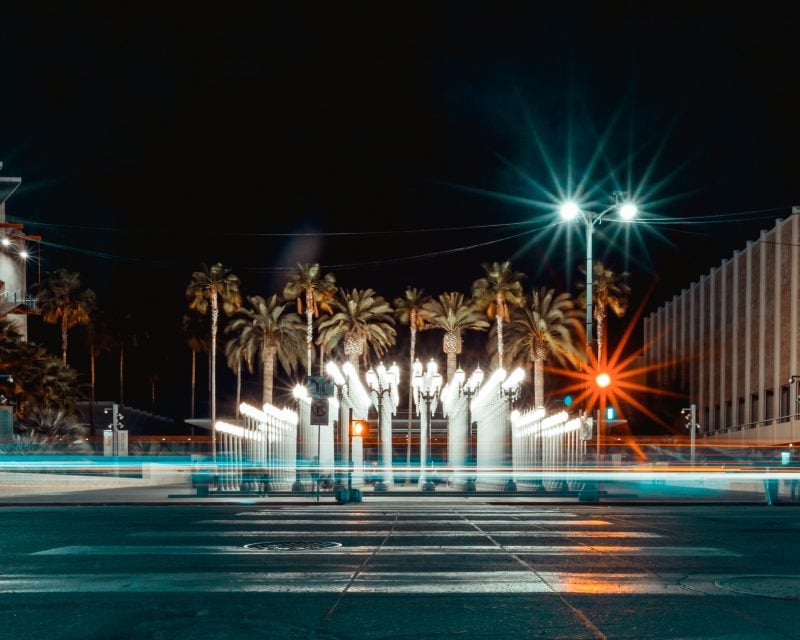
[0,499,800,640]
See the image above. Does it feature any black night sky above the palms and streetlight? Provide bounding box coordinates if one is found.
[0,1,800,416]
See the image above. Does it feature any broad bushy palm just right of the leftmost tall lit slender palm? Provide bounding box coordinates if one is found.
[225,295,305,405]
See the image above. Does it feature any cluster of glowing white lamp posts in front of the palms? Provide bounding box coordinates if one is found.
[217,363,586,491]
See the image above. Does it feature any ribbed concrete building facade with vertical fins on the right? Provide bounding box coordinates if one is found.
[644,207,800,446]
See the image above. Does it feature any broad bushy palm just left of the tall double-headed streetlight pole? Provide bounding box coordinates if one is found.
[508,287,581,407]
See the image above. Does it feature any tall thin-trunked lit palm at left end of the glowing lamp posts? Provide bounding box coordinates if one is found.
[186,262,242,464]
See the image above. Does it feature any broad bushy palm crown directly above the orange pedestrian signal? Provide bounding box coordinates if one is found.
[318,289,397,369]
